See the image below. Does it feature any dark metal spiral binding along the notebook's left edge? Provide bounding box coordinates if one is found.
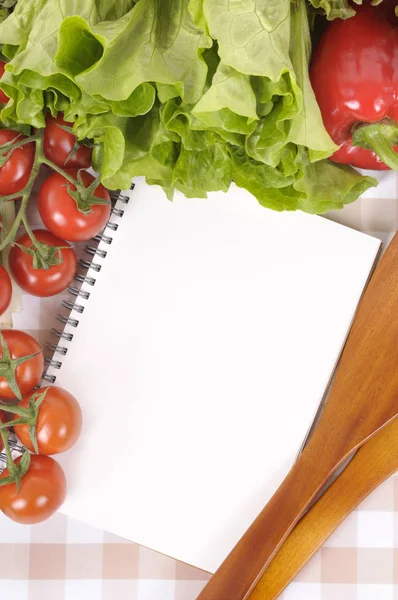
[43,184,131,384]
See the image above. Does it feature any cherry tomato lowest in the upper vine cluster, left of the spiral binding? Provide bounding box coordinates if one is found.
[9,229,77,297]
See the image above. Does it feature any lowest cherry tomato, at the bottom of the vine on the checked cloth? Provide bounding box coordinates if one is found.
[0,454,66,525]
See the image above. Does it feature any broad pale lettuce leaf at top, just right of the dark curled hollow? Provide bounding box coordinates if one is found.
[73,0,212,103]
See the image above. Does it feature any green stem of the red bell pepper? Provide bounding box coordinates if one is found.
[352,121,398,171]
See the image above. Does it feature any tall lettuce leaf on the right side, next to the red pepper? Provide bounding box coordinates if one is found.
[204,0,337,167]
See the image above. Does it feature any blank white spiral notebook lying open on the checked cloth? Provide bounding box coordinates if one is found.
[46,178,380,572]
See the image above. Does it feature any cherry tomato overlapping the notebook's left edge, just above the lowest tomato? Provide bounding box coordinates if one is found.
[14,386,82,454]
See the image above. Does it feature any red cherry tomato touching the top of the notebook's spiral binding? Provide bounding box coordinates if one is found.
[37,169,111,242]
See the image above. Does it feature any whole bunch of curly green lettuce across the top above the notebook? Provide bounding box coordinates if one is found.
[0,0,376,212]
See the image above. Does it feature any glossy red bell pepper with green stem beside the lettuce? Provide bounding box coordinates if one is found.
[310,0,398,169]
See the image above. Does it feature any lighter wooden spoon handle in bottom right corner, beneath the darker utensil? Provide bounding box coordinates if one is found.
[249,419,398,600]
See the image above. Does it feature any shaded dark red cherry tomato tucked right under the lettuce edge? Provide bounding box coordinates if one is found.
[44,113,93,169]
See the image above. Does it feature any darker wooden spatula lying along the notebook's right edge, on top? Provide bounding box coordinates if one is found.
[198,235,398,600]
